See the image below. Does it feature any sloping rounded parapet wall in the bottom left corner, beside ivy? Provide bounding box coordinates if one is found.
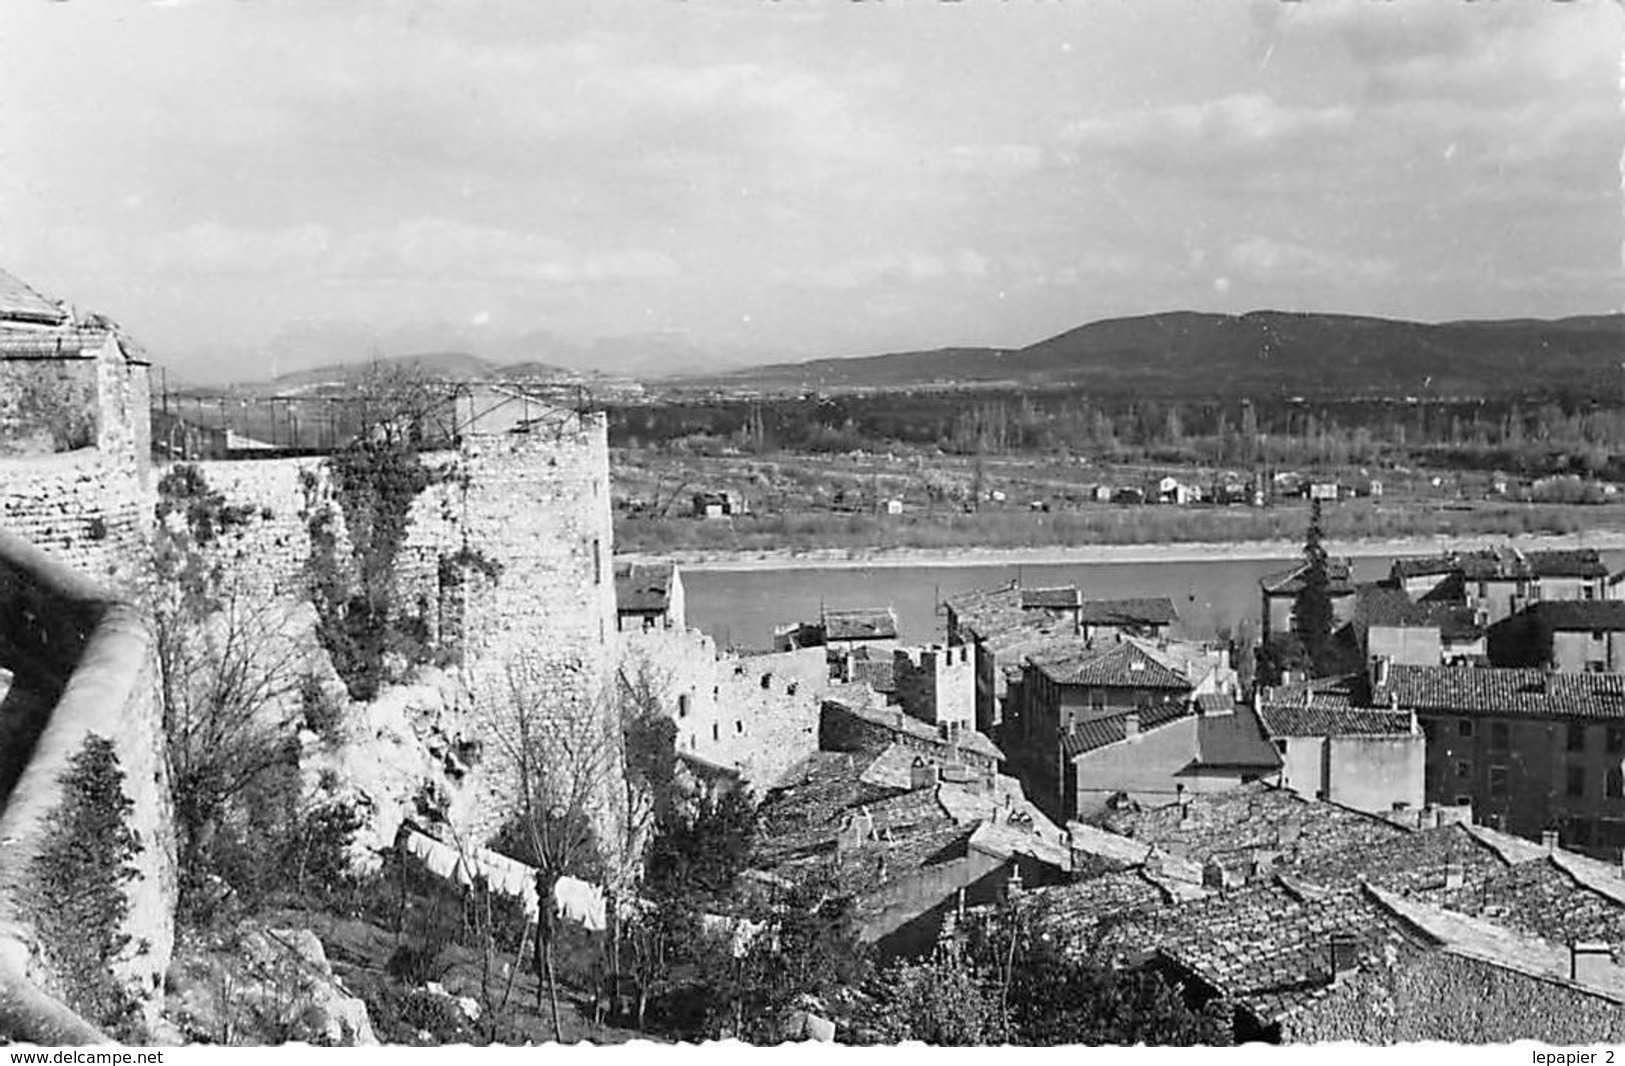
[0,531,176,1043]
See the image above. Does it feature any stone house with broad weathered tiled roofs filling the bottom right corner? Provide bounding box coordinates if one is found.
[1029,785,1625,1043]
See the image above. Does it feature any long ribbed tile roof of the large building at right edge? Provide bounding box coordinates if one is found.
[1372,663,1625,718]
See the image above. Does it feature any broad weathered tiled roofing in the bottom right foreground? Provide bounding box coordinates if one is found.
[1029,785,1625,1025]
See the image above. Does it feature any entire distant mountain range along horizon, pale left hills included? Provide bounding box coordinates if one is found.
[212,310,1625,407]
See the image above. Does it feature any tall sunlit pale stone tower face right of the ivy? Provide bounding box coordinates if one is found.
[458,411,621,842]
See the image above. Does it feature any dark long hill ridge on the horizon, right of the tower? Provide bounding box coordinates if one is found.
[687,310,1625,398]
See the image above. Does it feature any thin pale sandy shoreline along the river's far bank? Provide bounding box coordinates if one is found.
[621,530,1625,570]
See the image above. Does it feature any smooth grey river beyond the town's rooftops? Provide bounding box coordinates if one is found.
[683,551,1625,648]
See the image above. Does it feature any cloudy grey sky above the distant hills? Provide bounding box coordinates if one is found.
[0,0,1625,379]
